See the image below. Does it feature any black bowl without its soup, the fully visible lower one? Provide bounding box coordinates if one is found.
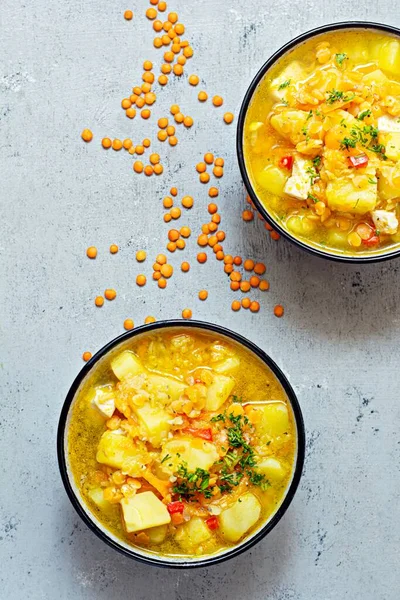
[57,320,305,568]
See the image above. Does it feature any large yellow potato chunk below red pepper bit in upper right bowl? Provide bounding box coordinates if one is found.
[326,175,378,215]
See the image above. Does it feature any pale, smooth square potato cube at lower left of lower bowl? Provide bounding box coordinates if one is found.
[120,492,171,533]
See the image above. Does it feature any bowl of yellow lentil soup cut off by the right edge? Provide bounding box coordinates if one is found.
[237,22,400,262]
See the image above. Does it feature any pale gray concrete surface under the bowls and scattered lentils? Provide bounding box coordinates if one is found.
[0,0,400,600]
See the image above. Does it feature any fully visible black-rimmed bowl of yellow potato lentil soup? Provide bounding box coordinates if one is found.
[58,321,305,567]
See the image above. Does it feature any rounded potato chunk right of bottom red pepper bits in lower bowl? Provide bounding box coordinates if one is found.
[219,492,261,542]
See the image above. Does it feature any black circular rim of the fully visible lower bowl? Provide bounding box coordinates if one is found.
[57,319,305,569]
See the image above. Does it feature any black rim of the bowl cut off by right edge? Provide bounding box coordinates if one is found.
[236,21,400,264]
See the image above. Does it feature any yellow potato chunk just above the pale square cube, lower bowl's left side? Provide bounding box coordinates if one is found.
[96,430,150,477]
